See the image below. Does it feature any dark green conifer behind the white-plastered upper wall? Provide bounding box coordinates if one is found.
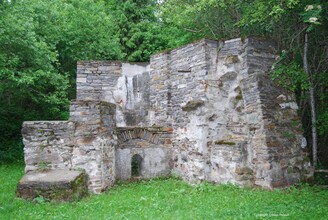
[108,0,166,61]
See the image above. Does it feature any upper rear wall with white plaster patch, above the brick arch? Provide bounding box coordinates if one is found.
[76,61,149,127]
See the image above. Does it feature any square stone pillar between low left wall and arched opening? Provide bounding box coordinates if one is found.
[70,100,117,193]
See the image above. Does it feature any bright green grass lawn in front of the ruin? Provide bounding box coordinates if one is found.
[0,165,328,220]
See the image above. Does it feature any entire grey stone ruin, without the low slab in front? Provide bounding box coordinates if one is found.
[23,38,312,192]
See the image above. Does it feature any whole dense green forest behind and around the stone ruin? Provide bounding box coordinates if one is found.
[0,0,328,168]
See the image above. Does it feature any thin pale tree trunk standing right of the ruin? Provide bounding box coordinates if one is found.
[303,32,318,167]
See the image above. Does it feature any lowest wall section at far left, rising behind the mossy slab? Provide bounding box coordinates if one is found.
[22,121,75,172]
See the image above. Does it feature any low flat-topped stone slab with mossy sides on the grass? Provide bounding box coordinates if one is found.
[16,169,88,201]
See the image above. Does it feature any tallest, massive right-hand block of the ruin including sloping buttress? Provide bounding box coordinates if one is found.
[150,38,311,188]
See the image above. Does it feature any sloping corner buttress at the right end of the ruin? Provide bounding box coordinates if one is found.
[242,38,312,188]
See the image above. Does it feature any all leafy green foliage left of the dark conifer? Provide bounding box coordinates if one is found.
[0,0,123,162]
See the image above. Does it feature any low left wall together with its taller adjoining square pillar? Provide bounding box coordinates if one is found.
[22,100,117,193]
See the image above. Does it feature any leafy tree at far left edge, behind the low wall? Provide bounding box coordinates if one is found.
[0,2,68,161]
